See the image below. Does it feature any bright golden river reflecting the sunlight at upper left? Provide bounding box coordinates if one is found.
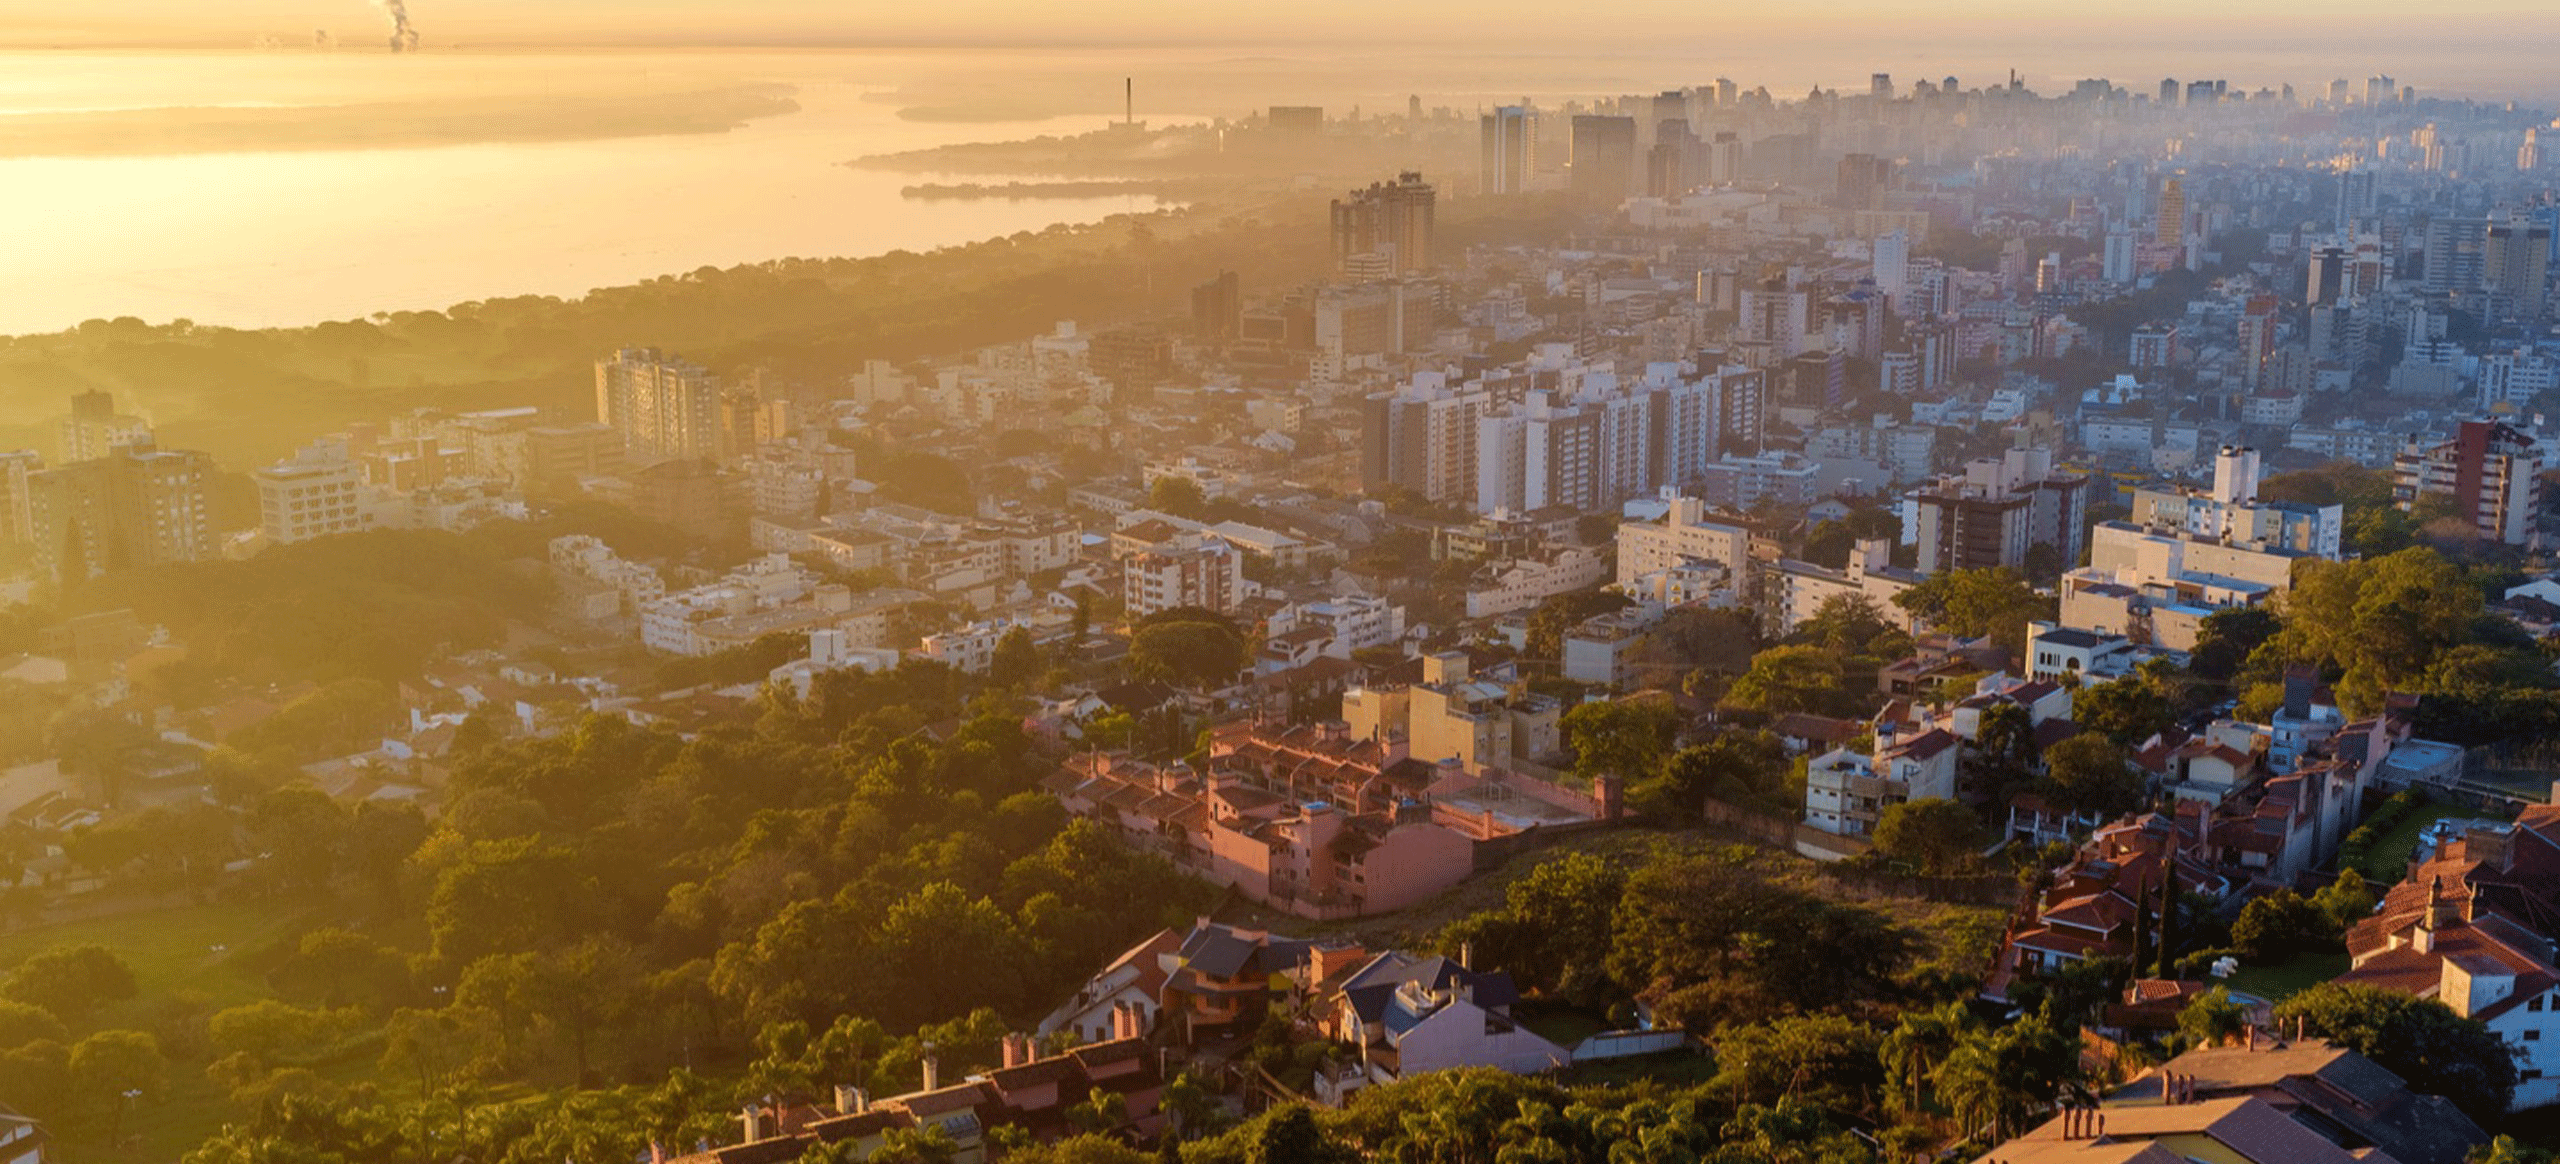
[0,51,1177,335]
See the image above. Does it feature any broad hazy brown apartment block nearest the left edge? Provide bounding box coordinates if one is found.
[26,443,215,581]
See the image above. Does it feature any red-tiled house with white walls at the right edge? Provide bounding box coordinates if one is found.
[2337,803,2560,1110]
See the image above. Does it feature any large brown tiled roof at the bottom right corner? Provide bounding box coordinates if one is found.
[2104,1038,2488,1164]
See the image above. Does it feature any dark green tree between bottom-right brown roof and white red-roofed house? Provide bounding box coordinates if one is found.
[2276,982,2516,1121]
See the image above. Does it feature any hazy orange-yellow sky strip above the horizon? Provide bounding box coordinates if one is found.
[15,0,2560,51]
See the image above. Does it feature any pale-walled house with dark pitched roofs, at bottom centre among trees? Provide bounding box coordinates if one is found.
[1316,952,1572,1105]
